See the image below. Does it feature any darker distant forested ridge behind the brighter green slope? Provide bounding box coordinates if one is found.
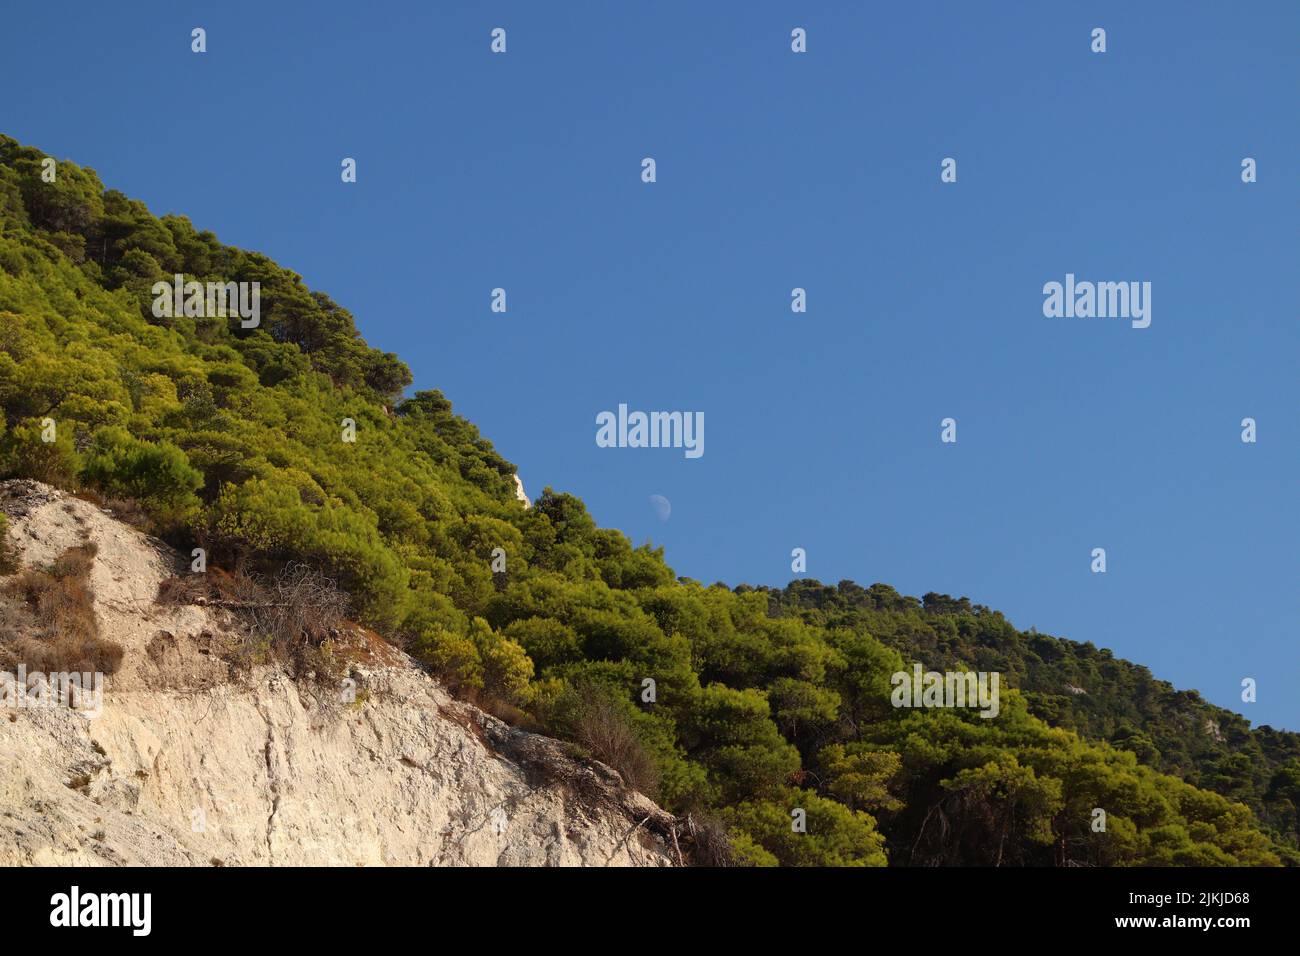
[761,580,1300,863]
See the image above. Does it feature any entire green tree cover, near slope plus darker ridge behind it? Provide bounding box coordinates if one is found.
[0,137,1300,865]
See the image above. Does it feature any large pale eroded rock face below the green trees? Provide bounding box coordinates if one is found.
[0,481,679,866]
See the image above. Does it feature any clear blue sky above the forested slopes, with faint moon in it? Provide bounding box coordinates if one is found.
[0,0,1300,730]
